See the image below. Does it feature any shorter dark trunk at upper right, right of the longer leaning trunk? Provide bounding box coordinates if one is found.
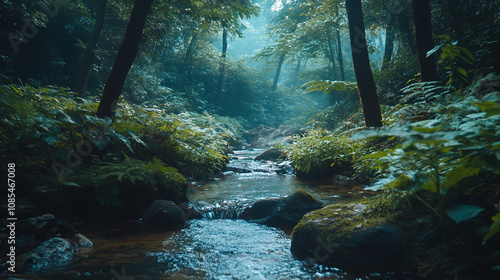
[411,0,438,82]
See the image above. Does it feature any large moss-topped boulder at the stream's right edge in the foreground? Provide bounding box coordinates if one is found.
[291,202,410,271]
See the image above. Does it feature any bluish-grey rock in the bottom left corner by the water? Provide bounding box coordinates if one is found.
[18,237,75,272]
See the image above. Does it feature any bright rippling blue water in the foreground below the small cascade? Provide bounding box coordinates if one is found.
[151,220,340,280]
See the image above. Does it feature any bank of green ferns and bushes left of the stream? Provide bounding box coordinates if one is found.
[0,85,243,205]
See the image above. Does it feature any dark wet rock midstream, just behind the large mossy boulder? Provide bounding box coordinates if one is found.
[243,191,325,228]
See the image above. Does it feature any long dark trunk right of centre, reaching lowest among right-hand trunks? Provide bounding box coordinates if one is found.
[346,0,382,127]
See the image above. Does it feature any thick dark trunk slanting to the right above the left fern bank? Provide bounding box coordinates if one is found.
[97,0,154,118]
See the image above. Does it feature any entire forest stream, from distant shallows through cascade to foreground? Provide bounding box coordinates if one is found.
[38,149,398,280]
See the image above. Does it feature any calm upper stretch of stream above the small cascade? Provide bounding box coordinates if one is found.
[188,149,369,205]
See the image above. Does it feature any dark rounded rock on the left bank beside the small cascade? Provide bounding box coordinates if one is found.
[142,200,186,229]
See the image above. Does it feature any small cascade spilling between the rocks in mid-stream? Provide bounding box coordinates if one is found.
[195,201,249,220]
